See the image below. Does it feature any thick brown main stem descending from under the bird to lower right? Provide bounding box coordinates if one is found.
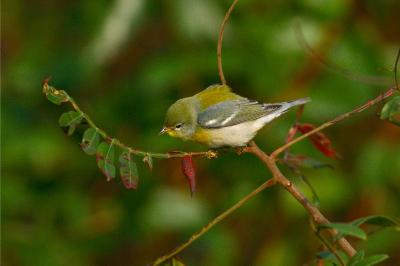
[246,141,356,257]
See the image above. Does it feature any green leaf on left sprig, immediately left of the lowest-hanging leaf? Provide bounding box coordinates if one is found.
[96,141,115,181]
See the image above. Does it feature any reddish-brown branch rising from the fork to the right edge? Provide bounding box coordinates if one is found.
[271,87,396,159]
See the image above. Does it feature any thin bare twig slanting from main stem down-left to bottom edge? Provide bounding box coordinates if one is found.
[151,178,276,266]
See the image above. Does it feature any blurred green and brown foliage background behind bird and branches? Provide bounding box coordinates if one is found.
[1,0,400,266]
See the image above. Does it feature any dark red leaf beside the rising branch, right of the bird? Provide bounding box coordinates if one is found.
[297,123,340,158]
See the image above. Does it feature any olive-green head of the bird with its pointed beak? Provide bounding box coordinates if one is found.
[160,97,197,140]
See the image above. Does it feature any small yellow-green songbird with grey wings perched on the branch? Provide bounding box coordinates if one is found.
[160,85,310,148]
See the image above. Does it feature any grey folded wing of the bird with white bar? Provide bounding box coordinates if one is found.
[197,98,283,128]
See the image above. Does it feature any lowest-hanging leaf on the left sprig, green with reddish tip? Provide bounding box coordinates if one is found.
[119,151,139,189]
